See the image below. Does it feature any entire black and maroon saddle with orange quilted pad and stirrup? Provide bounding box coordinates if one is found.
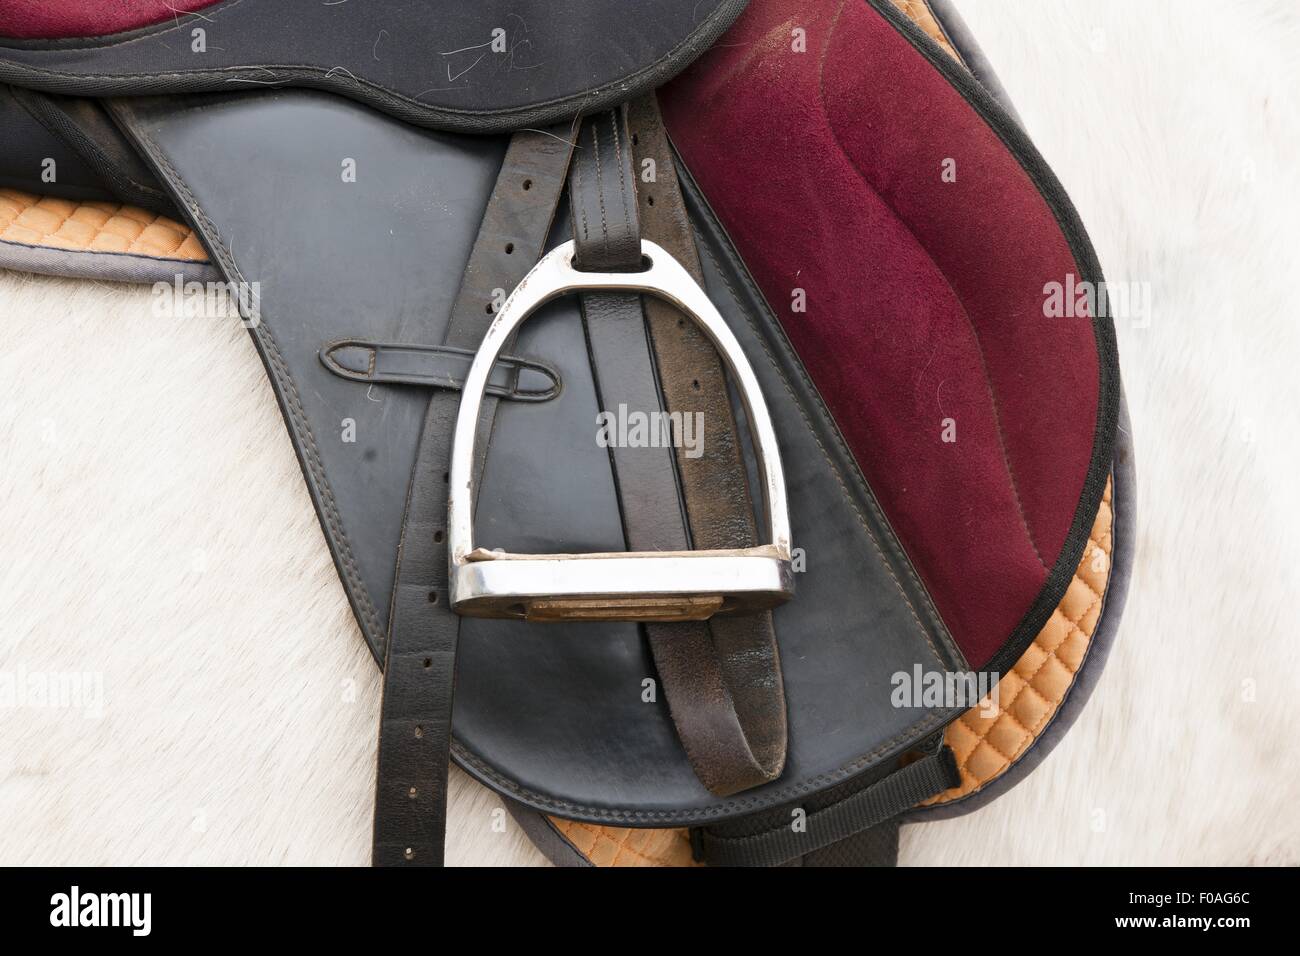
[0,0,1134,866]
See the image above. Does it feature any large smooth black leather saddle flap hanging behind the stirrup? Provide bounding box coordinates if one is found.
[114,91,966,826]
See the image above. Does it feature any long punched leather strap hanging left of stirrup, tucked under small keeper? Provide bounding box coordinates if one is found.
[373,127,573,866]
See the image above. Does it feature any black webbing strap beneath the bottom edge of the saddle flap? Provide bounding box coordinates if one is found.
[690,745,961,866]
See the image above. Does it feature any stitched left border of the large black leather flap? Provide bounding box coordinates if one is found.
[125,117,385,648]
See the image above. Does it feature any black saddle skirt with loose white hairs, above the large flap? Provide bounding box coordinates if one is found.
[0,0,746,133]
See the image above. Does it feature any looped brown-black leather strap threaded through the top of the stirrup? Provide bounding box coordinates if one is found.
[569,106,787,796]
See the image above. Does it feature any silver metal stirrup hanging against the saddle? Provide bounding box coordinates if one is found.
[447,239,794,620]
